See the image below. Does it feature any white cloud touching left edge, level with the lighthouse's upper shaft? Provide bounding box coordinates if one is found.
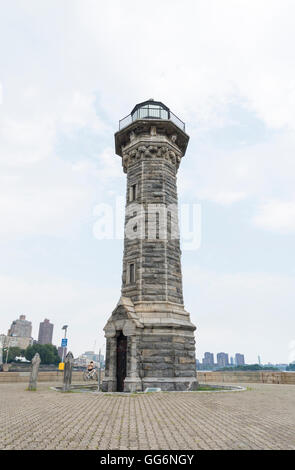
[0,159,91,239]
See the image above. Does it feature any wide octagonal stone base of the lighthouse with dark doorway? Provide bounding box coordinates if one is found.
[102,297,198,392]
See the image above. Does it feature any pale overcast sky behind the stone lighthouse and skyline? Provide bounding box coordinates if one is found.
[0,0,295,363]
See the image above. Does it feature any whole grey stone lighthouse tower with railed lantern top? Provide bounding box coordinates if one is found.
[102,100,197,392]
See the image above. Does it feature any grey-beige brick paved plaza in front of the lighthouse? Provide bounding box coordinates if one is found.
[0,383,295,450]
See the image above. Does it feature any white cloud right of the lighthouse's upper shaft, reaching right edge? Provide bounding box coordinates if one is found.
[179,132,295,233]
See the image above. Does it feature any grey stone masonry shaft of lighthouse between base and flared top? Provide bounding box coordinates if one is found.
[122,152,183,304]
